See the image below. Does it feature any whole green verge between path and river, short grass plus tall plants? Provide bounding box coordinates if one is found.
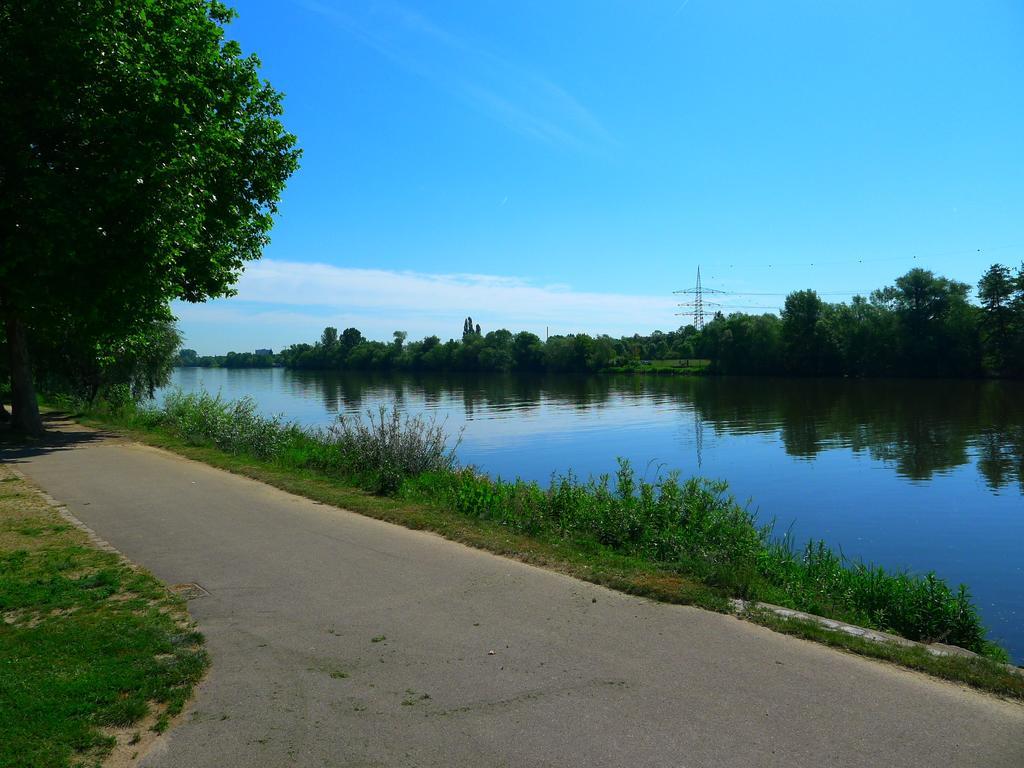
[66,395,1024,698]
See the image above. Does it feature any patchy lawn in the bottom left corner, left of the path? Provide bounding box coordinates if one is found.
[0,465,207,768]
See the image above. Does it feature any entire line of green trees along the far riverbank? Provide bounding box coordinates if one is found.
[180,264,1024,377]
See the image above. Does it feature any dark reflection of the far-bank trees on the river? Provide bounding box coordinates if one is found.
[286,371,1024,492]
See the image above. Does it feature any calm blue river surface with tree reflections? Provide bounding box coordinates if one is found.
[163,369,1024,664]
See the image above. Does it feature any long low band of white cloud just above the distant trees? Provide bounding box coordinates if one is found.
[175,259,681,351]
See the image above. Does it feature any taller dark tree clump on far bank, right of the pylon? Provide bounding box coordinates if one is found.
[697,264,1024,377]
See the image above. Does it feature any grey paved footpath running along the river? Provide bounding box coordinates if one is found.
[8,426,1024,768]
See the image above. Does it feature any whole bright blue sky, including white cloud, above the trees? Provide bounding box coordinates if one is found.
[175,0,1024,353]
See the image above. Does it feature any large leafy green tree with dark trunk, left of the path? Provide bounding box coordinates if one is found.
[0,0,299,431]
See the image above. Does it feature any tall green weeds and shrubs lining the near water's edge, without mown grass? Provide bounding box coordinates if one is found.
[92,393,1004,657]
